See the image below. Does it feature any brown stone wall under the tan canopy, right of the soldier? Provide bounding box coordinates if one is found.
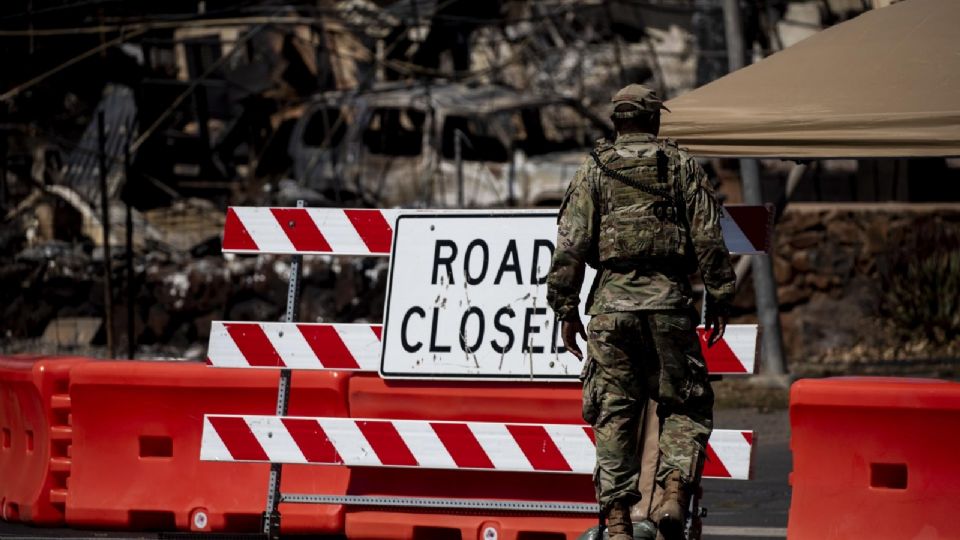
[756,203,960,375]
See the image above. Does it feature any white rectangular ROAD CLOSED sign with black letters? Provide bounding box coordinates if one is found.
[380,211,592,380]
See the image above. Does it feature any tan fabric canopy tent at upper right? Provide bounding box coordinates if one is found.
[662,0,960,158]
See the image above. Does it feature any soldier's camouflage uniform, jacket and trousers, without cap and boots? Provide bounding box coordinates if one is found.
[547,133,735,508]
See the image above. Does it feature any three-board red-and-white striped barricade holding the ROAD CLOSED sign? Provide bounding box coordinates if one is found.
[201,206,772,533]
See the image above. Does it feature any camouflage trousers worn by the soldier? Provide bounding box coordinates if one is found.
[581,310,713,508]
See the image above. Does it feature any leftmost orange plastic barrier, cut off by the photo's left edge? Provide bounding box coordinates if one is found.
[0,357,85,525]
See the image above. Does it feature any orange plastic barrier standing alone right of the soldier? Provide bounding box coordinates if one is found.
[787,378,960,540]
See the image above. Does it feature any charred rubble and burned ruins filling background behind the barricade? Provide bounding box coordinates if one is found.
[0,0,828,356]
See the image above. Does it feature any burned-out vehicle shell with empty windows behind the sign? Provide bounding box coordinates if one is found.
[289,84,610,207]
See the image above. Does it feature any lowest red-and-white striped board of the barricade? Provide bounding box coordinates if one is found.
[200,415,753,480]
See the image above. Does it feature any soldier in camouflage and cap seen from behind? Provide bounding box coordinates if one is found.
[547,84,735,540]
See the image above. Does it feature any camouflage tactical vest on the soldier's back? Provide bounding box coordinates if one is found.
[591,139,690,266]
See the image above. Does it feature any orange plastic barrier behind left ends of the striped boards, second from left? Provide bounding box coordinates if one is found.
[66,361,350,534]
